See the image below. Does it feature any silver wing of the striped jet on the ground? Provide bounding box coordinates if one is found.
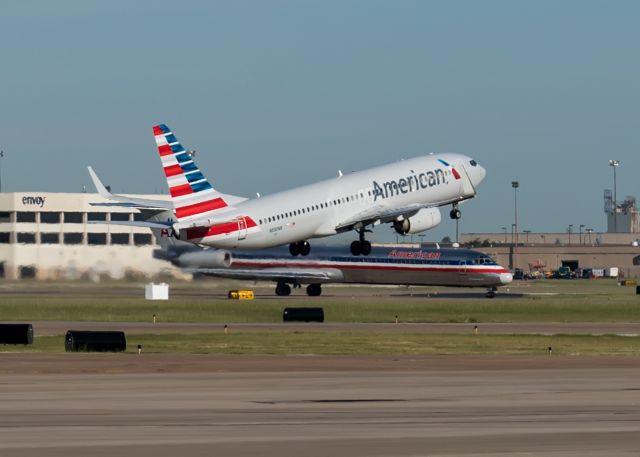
[183,268,344,283]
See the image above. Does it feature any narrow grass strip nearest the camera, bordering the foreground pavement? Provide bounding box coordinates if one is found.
[7,331,640,356]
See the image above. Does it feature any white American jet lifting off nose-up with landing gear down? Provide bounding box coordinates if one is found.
[89,124,486,256]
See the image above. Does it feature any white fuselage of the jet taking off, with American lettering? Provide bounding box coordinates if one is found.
[181,153,485,249]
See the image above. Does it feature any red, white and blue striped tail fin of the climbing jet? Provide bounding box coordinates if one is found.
[153,124,229,222]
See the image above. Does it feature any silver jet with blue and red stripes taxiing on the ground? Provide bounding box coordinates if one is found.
[154,242,513,298]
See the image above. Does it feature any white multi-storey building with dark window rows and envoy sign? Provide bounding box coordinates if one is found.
[0,192,181,280]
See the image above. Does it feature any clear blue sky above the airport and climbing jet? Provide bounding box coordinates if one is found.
[0,0,640,239]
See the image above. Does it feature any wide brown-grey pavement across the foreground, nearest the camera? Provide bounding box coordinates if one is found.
[0,354,640,457]
